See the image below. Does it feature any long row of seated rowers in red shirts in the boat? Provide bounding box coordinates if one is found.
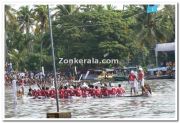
[28,84,126,98]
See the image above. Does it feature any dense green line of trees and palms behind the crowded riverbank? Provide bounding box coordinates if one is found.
[5,5,175,71]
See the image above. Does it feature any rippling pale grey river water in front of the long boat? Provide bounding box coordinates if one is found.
[5,80,175,119]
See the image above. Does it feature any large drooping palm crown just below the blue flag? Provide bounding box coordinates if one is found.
[126,5,173,47]
